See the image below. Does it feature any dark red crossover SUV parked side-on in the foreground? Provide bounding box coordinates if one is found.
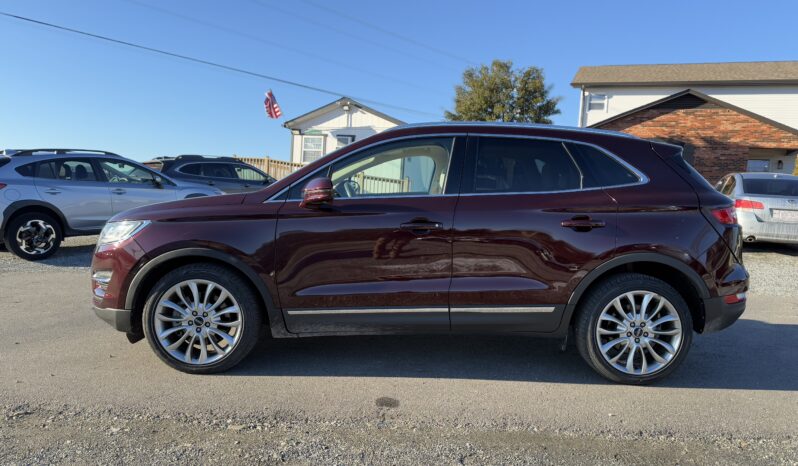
[92,123,748,383]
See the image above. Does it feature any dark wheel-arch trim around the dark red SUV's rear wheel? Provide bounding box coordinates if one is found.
[563,253,711,333]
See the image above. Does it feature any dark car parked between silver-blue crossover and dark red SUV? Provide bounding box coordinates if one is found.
[144,155,275,193]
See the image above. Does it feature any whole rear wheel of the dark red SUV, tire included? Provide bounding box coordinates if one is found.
[575,273,693,384]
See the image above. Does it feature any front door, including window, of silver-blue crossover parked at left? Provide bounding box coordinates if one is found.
[98,159,177,213]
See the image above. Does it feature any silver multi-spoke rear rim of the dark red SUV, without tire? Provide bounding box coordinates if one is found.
[596,290,682,375]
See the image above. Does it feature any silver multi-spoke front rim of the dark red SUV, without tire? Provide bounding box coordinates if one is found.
[154,280,244,365]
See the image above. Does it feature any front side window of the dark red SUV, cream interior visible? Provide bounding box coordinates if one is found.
[330,138,452,197]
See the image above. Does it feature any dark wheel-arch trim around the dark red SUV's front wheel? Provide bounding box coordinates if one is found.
[125,247,293,337]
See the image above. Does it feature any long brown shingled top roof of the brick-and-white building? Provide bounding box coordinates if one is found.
[571,61,798,87]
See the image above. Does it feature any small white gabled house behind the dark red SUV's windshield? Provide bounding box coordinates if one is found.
[283,97,404,164]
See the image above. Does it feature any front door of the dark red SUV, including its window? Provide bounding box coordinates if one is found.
[276,137,464,333]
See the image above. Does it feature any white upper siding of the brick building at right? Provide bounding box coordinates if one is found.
[581,86,798,128]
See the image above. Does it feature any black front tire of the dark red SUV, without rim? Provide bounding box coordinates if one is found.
[142,263,263,374]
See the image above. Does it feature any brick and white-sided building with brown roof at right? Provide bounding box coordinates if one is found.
[572,62,798,183]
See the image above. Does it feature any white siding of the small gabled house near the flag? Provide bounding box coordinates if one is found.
[291,105,396,163]
